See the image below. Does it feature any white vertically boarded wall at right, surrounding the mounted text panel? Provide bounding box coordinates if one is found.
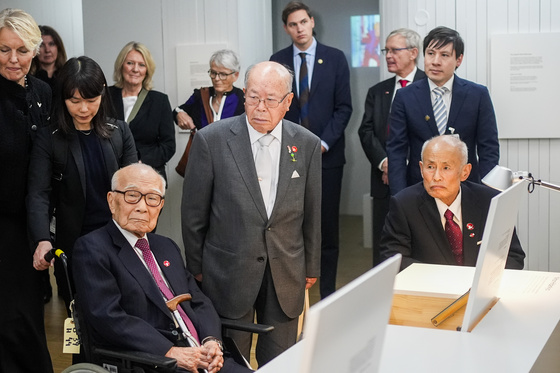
[381,0,560,271]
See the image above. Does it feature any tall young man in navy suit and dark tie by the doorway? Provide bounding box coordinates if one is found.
[270,1,352,298]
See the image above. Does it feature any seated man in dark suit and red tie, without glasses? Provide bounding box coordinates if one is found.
[380,135,525,270]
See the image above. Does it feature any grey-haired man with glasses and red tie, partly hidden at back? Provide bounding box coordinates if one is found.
[358,28,426,266]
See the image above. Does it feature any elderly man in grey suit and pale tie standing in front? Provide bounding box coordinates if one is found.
[181,62,321,366]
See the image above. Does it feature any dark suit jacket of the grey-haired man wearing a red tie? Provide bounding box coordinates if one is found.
[358,69,426,198]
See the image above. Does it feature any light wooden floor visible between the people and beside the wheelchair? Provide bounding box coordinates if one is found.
[45,216,372,373]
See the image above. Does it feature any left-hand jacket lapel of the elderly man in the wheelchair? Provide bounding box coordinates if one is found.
[108,222,171,318]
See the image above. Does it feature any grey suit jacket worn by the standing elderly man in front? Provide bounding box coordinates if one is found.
[182,114,321,319]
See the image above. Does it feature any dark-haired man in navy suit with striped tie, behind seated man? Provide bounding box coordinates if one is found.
[387,27,500,195]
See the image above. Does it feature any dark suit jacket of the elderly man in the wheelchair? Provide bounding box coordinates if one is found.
[73,221,221,355]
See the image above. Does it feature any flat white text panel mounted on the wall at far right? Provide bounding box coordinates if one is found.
[490,33,560,139]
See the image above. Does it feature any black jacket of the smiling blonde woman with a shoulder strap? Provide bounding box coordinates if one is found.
[109,86,175,180]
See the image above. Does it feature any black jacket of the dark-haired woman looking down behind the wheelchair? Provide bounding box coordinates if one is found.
[27,121,138,257]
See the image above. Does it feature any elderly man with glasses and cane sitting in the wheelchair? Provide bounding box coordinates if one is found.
[73,163,250,373]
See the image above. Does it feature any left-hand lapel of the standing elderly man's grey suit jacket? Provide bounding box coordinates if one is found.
[227,114,268,221]
